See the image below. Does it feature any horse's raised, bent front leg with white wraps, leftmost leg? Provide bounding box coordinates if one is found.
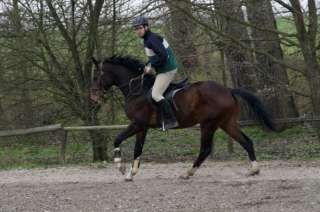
[114,122,142,174]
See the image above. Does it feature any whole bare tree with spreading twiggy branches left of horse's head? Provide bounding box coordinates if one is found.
[3,0,107,160]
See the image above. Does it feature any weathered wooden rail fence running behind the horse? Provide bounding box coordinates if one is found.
[0,116,320,163]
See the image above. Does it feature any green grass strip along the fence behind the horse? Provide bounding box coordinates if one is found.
[0,127,320,169]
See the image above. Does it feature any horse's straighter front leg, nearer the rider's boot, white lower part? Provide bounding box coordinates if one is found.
[126,129,148,181]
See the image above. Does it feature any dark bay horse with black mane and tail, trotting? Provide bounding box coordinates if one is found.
[90,56,275,180]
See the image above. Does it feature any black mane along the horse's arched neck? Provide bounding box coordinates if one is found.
[103,55,144,74]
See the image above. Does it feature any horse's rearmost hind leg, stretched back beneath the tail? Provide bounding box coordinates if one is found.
[222,124,260,176]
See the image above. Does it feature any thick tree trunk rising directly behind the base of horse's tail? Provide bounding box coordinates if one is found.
[216,0,257,119]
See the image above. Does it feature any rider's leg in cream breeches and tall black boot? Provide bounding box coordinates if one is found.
[151,70,178,130]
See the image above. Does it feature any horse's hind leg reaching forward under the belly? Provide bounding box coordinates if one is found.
[180,123,216,179]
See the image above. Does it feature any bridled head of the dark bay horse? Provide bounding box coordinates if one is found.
[90,57,115,103]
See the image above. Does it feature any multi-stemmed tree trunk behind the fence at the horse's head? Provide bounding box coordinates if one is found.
[40,0,107,161]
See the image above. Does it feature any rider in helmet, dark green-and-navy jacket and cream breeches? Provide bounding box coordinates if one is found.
[132,16,178,130]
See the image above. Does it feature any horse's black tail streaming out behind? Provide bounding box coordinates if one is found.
[231,88,277,131]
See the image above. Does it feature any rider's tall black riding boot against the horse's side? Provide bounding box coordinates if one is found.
[158,99,178,131]
